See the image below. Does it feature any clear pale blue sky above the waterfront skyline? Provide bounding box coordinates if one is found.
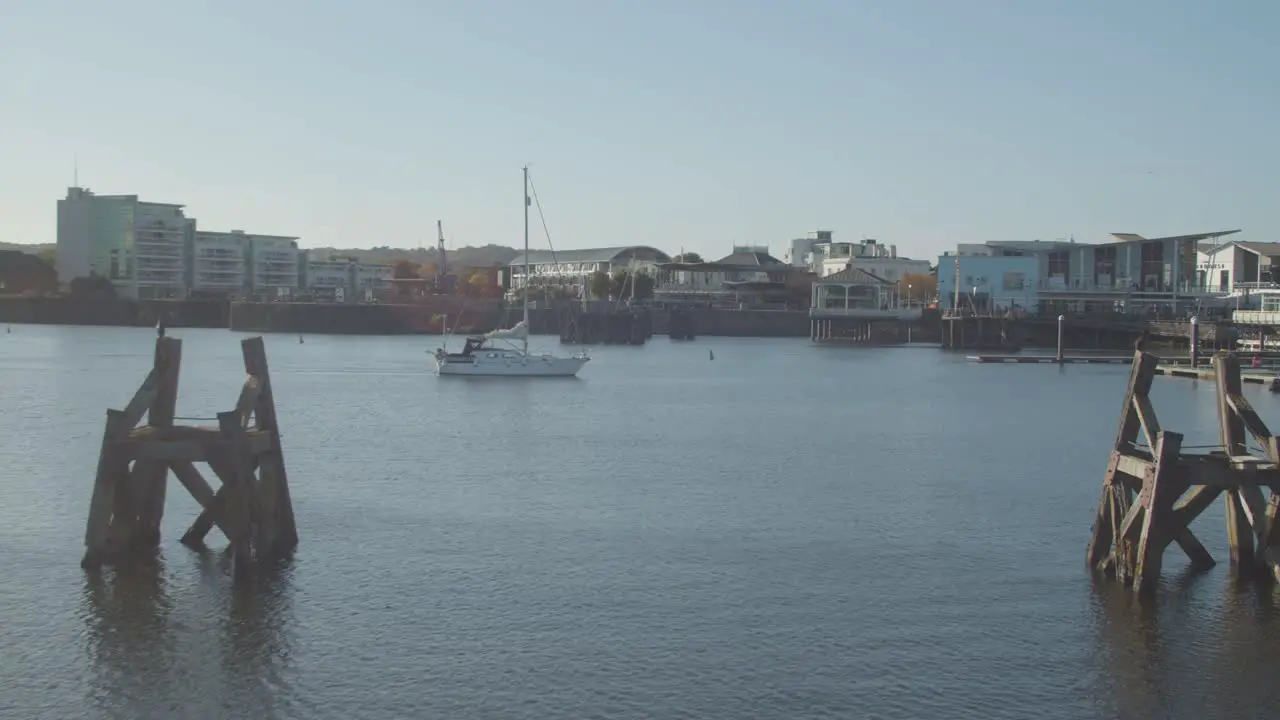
[0,0,1280,258]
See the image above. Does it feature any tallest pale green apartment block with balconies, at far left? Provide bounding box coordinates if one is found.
[58,187,193,297]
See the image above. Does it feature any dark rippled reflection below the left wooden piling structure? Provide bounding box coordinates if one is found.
[82,552,293,719]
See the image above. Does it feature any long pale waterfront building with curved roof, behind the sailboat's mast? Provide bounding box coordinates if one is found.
[504,245,671,290]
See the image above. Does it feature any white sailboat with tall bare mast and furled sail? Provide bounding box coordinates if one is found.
[435,165,590,378]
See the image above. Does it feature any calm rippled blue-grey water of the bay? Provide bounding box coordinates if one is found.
[0,325,1280,720]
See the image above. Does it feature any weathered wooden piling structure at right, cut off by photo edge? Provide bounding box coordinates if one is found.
[1088,350,1280,592]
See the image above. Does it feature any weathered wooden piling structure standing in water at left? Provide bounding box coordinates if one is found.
[82,337,298,573]
